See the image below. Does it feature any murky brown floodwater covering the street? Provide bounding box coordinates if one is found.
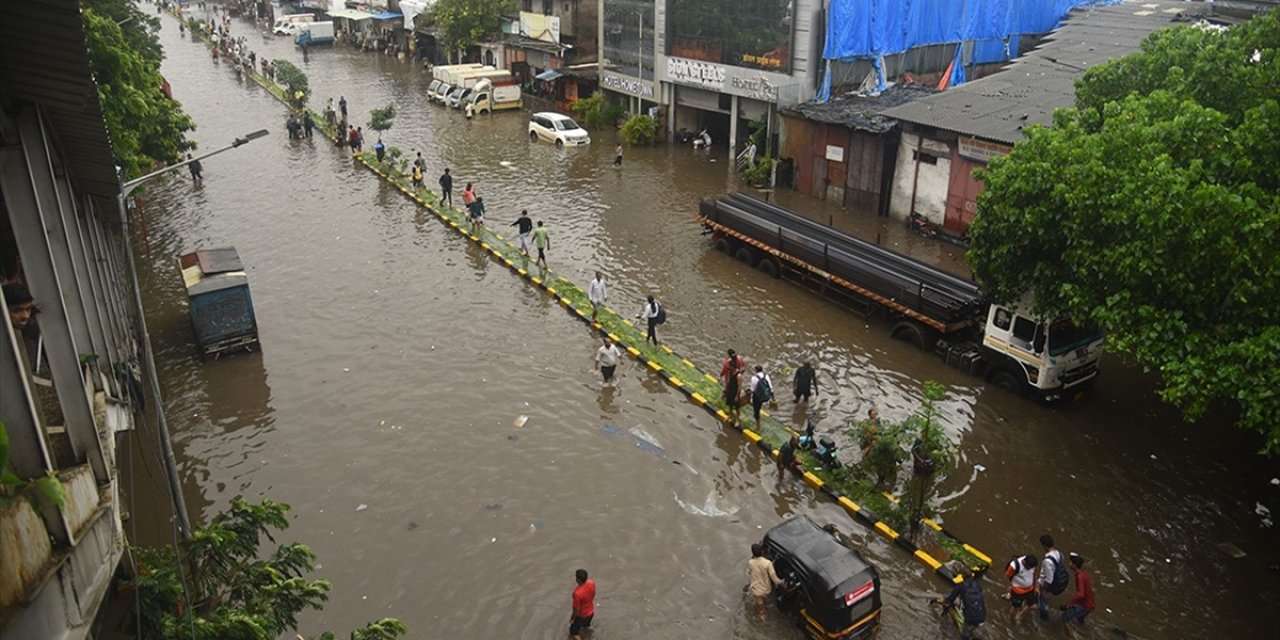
[137,11,1280,640]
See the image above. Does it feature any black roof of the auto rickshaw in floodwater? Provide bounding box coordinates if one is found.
[764,516,876,598]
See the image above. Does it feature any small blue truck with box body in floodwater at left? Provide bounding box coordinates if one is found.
[178,247,257,357]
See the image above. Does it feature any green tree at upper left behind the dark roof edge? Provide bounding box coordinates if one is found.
[82,0,196,178]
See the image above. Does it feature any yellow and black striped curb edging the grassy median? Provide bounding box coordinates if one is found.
[183,16,991,582]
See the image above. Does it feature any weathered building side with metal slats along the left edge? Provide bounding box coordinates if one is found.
[0,0,140,640]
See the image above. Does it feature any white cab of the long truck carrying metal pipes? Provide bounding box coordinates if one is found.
[982,305,1106,401]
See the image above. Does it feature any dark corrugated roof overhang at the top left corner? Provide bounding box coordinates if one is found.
[0,0,120,210]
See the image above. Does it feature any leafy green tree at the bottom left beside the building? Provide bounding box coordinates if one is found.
[128,498,407,640]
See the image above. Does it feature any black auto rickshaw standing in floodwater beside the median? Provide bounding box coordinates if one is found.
[764,516,881,640]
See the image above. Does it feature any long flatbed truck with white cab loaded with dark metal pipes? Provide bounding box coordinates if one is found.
[698,193,1103,401]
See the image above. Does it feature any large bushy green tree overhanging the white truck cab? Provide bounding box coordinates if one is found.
[969,12,1280,452]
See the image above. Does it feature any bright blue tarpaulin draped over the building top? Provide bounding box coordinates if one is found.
[822,0,1117,63]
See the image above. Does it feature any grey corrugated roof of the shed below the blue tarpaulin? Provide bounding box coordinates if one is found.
[884,0,1207,145]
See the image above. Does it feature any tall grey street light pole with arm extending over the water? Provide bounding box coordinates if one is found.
[116,129,270,540]
